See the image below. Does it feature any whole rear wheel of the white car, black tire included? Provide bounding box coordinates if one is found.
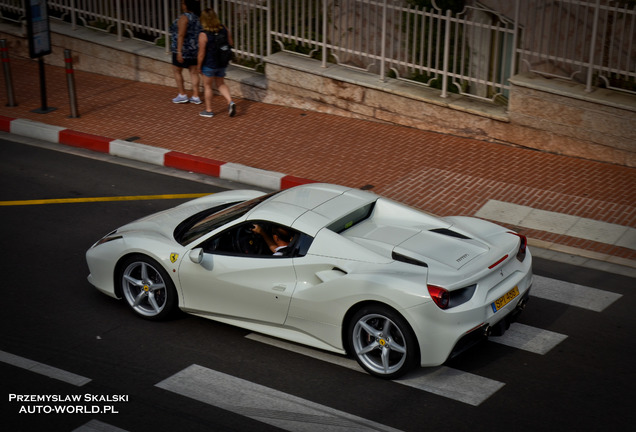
[348,305,419,379]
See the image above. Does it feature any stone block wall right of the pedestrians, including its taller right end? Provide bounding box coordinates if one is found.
[266,53,636,167]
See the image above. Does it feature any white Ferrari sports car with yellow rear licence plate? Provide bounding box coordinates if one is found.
[86,184,532,378]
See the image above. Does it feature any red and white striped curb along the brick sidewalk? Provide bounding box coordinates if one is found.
[0,116,314,190]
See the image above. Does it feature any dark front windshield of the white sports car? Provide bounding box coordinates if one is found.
[174,192,278,246]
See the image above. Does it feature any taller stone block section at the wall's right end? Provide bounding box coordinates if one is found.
[509,74,636,166]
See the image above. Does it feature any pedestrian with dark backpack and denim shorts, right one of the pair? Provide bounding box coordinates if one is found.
[197,8,236,117]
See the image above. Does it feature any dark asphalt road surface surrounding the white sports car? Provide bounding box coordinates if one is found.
[0,134,636,432]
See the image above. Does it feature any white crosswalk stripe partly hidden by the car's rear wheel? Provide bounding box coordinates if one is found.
[246,333,504,406]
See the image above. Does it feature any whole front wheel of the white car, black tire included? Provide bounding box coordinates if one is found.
[119,255,177,321]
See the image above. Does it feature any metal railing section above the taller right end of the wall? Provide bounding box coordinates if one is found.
[519,0,636,94]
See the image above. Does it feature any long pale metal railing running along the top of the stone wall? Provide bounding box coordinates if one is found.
[0,0,636,102]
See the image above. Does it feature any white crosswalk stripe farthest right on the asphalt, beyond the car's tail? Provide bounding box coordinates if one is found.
[530,275,622,312]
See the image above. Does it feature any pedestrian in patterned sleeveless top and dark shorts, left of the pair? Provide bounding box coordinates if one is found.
[170,0,201,104]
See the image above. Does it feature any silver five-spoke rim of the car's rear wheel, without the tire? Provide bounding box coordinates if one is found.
[352,313,407,376]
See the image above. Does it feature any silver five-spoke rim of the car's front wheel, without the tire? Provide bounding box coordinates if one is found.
[122,261,168,317]
